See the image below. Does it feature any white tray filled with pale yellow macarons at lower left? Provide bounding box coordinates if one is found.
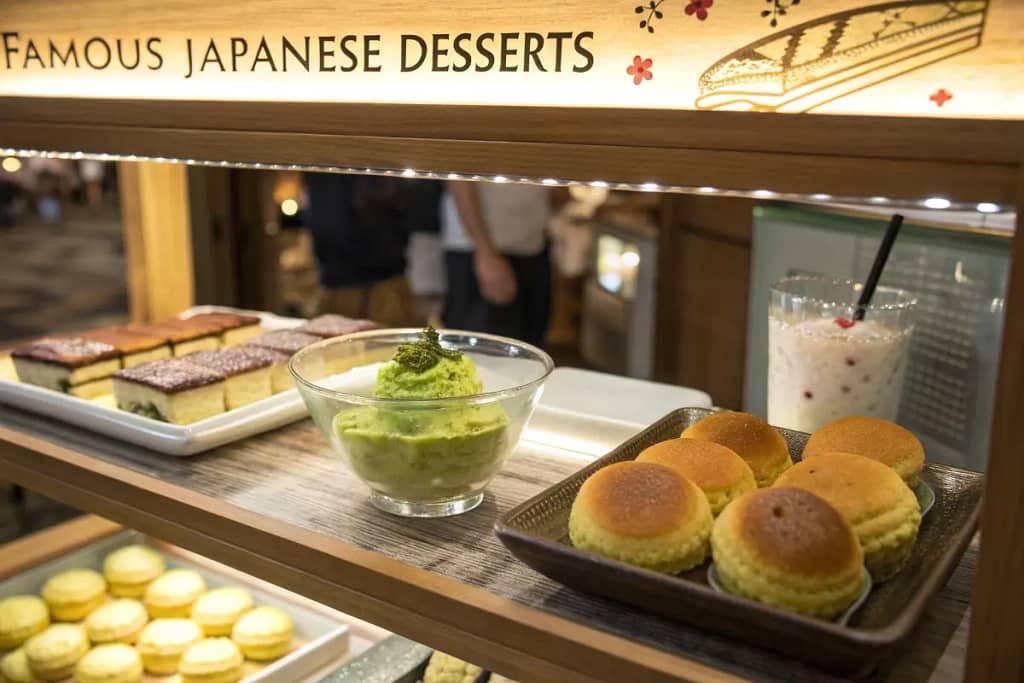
[0,529,358,683]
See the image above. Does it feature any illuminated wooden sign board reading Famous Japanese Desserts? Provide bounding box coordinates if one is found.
[0,0,1024,118]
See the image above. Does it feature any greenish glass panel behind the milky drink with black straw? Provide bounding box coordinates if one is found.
[744,206,1013,470]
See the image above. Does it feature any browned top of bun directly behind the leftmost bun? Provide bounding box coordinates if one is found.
[637,438,753,490]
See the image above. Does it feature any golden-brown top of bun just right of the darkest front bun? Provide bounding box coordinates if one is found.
[775,453,913,523]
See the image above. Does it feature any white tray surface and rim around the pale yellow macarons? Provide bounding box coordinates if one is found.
[0,530,350,683]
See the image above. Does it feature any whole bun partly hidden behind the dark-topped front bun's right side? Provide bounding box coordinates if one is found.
[776,453,921,583]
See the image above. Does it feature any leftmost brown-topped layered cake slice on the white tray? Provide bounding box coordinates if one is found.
[10,337,121,392]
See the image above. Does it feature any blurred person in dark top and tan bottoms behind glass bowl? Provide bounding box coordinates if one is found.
[305,173,437,327]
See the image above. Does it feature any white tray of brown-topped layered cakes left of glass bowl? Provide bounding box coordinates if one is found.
[0,306,376,456]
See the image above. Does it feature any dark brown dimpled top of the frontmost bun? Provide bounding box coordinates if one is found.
[730,486,863,577]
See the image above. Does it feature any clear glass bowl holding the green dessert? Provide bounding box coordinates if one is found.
[289,329,554,517]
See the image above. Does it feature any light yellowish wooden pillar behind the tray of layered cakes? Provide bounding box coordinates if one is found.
[118,162,195,322]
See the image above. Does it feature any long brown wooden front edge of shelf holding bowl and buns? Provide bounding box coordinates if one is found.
[0,429,742,683]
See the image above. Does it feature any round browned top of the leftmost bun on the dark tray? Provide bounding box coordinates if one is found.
[577,462,703,537]
